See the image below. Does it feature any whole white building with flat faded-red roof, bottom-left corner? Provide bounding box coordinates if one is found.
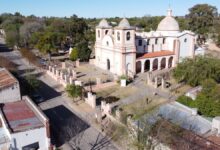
[0,97,51,150]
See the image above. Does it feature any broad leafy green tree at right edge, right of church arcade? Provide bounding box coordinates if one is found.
[173,56,220,86]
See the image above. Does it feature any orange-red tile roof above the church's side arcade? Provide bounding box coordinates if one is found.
[137,50,174,59]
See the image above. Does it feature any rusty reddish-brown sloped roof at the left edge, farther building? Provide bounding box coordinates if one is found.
[0,68,17,89]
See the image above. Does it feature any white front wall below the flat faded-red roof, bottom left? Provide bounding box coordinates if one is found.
[11,127,50,150]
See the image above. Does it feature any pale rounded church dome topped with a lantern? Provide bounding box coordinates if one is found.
[157,9,180,31]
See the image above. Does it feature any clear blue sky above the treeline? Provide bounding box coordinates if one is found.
[0,0,220,18]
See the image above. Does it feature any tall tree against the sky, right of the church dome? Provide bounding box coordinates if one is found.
[187,4,218,35]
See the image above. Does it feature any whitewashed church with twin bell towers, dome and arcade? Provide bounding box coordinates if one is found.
[95,9,199,77]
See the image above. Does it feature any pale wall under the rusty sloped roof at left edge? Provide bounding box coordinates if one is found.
[0,83,21,103]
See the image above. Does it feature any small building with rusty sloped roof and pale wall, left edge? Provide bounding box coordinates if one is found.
[0,68,21,103]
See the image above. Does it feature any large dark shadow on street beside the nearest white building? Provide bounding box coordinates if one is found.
[44,105,89,147]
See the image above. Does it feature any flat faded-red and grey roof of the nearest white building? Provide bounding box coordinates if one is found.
[3,100,44,132]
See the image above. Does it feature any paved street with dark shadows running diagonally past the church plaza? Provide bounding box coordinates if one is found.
[0,40,117,150]
